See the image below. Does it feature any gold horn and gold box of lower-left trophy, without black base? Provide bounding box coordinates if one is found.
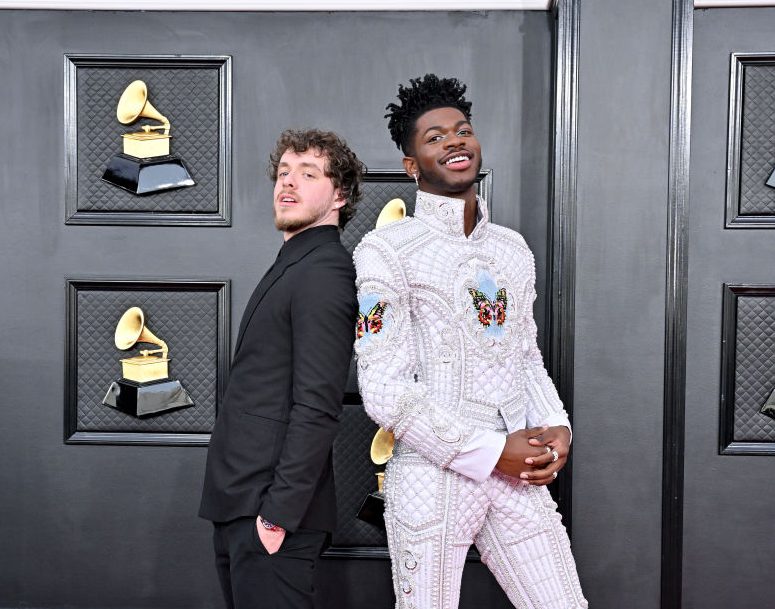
[114,307,170,383]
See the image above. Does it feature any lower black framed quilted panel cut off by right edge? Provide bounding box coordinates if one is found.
[719,285,775,455]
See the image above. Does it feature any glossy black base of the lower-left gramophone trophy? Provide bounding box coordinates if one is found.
[102,379,194,418]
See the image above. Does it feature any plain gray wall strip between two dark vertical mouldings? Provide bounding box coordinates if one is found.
[573,0,671,609]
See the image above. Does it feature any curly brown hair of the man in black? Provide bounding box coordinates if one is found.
[267,129,366,228]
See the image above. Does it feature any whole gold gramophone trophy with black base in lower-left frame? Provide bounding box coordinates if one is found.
[102,307,194,417]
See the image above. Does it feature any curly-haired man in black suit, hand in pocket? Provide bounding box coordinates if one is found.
[199,129,365,609]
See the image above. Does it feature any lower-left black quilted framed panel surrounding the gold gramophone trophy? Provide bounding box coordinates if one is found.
[65,279,230,445]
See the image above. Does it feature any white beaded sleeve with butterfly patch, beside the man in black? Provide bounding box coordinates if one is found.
[354,235,505,481]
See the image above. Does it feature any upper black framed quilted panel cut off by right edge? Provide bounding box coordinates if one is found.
[726,51,775,228]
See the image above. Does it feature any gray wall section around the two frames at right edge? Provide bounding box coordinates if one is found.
[684,8,775,609]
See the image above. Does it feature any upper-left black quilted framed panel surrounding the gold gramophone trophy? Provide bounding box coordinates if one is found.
[64,54,231,226]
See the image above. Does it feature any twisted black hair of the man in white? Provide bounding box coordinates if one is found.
[385,74,471,154]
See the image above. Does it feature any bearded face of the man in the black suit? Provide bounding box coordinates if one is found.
[274,149,345,241]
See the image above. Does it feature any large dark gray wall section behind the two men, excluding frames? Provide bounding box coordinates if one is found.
[0,11,556,609]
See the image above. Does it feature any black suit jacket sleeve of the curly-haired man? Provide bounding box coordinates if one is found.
[260,248,357,531]
